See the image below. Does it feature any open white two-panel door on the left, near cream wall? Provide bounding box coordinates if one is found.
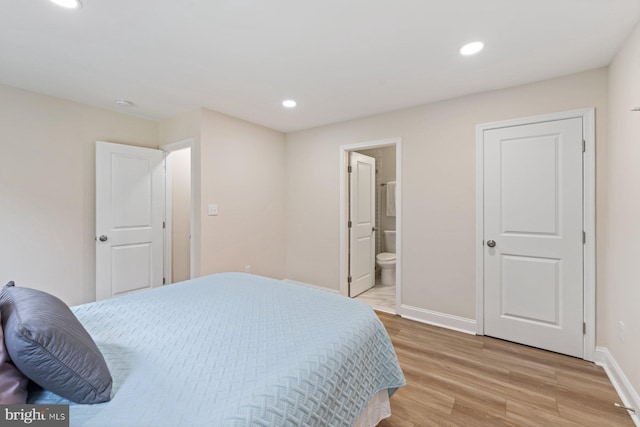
[96,141,164,300]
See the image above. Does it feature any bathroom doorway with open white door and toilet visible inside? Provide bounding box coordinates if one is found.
[340,138,402,314]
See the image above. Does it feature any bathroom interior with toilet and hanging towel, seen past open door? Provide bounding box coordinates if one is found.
[356,145,396,314]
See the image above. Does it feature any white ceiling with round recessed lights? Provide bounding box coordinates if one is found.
[0,0,640,132]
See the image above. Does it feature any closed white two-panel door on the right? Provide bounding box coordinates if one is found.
[484,118,584,357]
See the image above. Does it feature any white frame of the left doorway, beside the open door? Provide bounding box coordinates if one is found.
[160,138,200,285]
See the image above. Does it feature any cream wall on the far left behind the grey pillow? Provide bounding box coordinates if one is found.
[0,85,158,305]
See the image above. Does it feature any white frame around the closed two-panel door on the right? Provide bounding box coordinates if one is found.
[476,107,596,362]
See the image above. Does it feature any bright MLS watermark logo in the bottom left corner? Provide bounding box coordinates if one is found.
[0,405,69,427]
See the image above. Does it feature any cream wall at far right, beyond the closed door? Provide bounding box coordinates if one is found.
[598,21,640,398]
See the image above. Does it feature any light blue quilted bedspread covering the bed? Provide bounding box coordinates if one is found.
[29,273,405,427]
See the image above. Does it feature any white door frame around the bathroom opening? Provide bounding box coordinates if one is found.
[339,137,402,313]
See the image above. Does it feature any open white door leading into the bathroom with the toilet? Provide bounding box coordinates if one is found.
[349,152,376,297]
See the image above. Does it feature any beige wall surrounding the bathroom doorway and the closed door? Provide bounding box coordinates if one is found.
[286,69,608,319]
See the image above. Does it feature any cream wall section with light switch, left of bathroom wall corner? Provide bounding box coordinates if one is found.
[200,109,285,278]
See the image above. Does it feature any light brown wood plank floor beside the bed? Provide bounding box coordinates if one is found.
[377,312,634,427]
